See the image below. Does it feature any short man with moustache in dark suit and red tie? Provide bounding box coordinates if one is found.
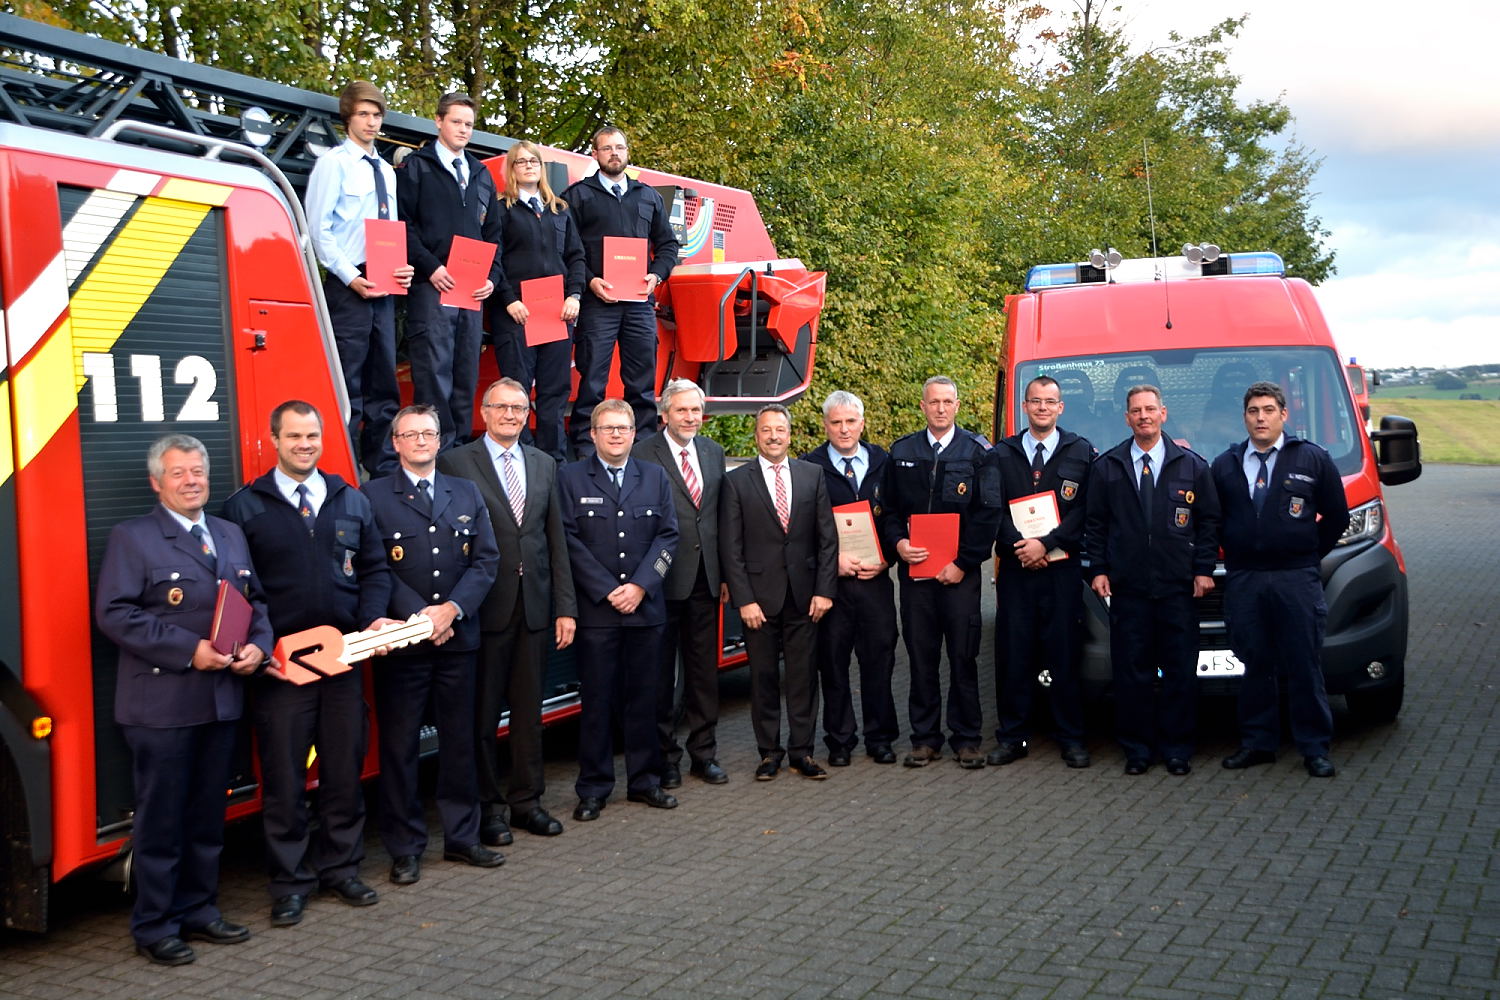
[719,403,839,781]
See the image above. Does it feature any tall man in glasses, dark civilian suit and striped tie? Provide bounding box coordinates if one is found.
[438,378,578,847]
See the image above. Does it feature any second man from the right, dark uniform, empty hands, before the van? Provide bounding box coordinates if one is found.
[1083,385,1220,775]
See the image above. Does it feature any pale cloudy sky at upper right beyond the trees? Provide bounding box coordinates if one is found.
[1086,0,1500,369]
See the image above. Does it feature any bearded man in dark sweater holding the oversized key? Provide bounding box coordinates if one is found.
[224,400,390,927]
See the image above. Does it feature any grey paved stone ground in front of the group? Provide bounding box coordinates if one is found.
[0,466,1500,1000]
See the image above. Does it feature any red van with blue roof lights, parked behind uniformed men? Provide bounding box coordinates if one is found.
[995,246,1422,721]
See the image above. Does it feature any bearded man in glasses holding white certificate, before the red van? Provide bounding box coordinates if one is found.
[986,375,1094,768]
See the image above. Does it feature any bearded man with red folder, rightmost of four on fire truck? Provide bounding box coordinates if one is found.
[563,126,680,456]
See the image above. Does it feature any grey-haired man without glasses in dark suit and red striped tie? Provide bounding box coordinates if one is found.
[632,378,729,789]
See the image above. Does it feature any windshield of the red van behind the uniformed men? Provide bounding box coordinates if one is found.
[1011,346,1364,475]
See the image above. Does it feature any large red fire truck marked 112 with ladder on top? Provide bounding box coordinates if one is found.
[0,15,825,930]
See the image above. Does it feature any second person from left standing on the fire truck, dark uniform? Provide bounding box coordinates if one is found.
[396,93,501,448]
